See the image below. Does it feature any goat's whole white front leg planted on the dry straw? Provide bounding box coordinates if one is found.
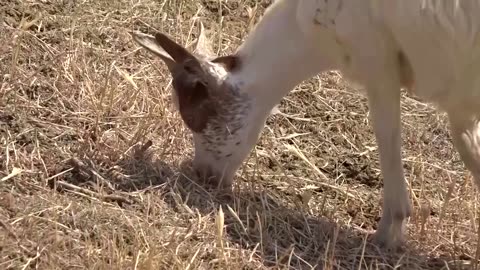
[368,83,411,249]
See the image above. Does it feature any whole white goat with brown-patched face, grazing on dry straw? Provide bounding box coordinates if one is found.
[133,0,480,247]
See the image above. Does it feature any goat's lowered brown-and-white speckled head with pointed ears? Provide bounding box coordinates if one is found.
[132,23,262,188]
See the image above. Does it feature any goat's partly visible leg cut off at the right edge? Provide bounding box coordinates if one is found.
[448,111,480,189]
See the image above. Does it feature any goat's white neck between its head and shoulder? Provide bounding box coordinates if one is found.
[233,1,334,112]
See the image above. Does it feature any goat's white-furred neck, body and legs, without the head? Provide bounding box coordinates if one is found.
[211,0,480,247]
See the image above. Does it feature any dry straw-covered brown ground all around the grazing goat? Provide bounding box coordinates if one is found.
[0,0,478,269]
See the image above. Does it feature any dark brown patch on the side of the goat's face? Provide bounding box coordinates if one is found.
[174,78,216,133]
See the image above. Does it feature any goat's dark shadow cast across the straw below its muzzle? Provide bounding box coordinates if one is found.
[51,142,459,269]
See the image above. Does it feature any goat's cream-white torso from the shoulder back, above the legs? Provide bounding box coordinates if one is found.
[294,0,480,110]
